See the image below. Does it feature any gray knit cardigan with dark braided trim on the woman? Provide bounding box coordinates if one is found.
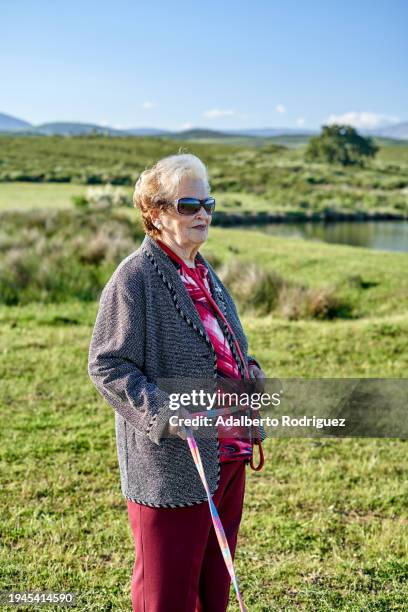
[88,235,265,508]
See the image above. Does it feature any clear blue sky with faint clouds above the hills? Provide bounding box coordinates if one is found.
[0,0,408,130]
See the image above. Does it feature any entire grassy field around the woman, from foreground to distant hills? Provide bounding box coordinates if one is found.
[0,138,408,612]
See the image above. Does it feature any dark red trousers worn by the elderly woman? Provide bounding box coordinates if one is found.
[127,460,246,612]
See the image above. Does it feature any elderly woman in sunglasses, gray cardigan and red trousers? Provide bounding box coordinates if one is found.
[88,154,264,612]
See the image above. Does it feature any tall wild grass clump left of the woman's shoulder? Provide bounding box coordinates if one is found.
[0,209,144,305]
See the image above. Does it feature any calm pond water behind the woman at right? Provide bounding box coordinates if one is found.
[241,221,408,252]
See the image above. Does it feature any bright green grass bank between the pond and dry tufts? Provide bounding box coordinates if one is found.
[203,227,408,317]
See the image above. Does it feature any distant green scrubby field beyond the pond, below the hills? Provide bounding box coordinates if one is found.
[0,136,408,217]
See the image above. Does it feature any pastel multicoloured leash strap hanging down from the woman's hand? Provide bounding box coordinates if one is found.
[185,426,248,612]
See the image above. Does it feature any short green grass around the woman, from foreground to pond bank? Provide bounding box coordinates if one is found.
[0,228,408,612]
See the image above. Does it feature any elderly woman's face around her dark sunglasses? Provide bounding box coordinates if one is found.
[158,177,212,247]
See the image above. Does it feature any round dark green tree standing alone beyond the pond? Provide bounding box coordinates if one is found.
[305,123,378,166]
